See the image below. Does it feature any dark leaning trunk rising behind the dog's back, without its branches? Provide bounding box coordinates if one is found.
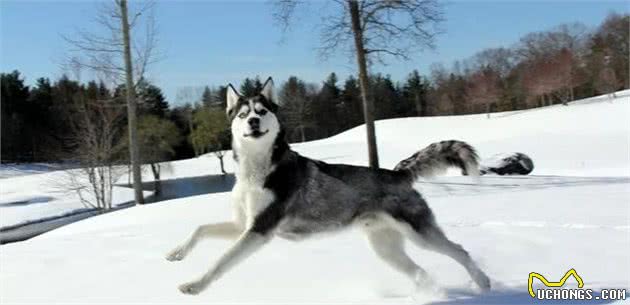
[348,0,379,168]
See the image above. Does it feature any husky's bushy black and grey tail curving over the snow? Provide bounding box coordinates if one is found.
[394,140,479,179]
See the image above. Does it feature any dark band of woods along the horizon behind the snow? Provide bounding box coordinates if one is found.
[0,13,630,169]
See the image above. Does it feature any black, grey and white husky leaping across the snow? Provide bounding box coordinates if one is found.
[167,78,490,294]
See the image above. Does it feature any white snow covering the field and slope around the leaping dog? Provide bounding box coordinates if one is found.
[0,91,630,304]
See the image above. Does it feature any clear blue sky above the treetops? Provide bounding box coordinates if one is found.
[0,0,629,103]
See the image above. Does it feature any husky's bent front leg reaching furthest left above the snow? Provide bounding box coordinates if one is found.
[166,222,243,261]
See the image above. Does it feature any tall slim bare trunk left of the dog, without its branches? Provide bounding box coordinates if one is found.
[119,0,144,204]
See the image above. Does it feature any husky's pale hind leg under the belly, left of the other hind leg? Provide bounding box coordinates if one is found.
[366,227,431,286]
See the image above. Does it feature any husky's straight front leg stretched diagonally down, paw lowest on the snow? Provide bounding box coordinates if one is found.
[179,230,270,294]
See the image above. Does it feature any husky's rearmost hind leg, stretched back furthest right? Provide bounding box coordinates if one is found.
[411,221,490,291]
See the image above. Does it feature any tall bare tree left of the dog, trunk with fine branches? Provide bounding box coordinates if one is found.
[64,0,157,204]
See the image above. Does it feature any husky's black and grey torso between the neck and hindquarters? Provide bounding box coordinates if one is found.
[267,152,432,238]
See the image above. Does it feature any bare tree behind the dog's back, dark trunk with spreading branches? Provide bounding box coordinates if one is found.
[274,0,443,168]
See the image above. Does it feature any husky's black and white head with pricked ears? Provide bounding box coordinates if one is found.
[227,77,280,144]
